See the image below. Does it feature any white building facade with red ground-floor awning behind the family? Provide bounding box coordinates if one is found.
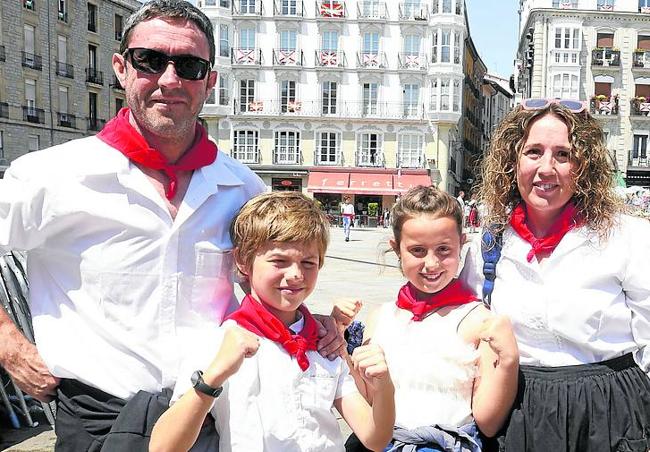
[199,0,467,219]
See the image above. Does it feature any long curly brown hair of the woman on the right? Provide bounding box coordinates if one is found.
[478,103,622,237]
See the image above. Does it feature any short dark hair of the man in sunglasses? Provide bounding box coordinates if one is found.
[120,0,216,66]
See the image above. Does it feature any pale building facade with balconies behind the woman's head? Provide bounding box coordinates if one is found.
[515,0,650,187]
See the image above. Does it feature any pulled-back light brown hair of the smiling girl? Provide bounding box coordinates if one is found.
[390,185,463,247]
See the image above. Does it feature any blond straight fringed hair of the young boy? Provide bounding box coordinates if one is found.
[230,192,329,268]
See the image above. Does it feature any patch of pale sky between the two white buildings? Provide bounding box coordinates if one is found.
[465,0,519,79]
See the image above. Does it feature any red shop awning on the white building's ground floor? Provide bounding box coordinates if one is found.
[307,171,431,195]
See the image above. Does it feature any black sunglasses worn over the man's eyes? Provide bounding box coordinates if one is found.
[124,47,210,80]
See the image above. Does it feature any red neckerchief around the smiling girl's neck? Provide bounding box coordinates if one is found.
[397,279,478,322]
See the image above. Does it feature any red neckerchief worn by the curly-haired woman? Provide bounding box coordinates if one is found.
[510,201,581,262]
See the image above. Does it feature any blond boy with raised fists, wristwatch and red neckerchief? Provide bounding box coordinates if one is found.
[150,192,395,452]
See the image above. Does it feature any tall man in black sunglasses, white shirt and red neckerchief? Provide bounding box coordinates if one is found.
[0,0,290,451]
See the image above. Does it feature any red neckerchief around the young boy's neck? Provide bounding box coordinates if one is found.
[226,295,318,371]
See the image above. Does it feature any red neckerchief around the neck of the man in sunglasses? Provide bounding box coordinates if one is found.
[97,108,217,201]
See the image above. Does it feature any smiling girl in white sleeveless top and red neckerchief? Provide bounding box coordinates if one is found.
[344,186,518,452]
